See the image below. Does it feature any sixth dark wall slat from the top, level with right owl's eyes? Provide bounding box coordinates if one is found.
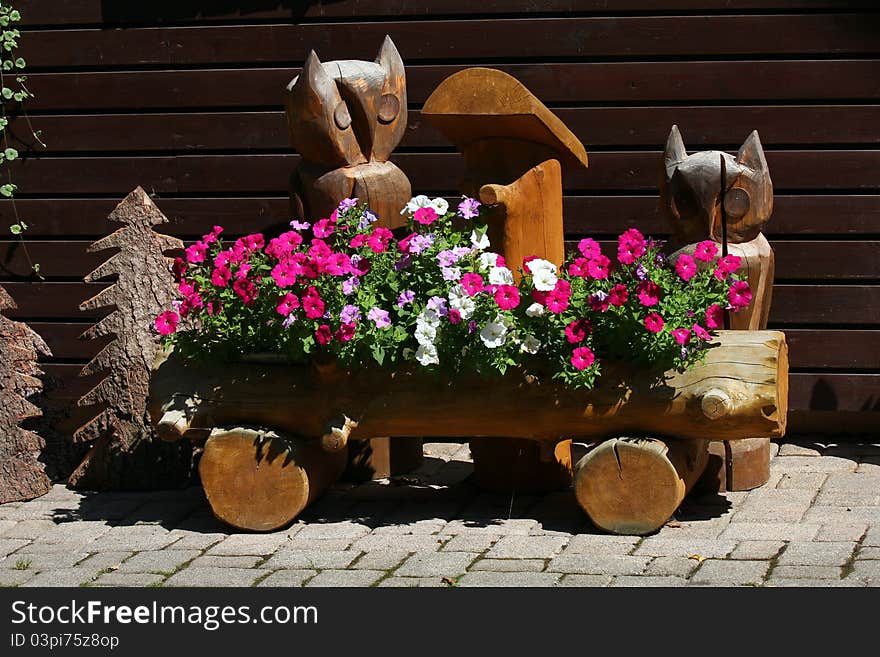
[0,194,880,240]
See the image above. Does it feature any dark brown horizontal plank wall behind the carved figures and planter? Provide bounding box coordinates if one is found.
[0,0,880,476]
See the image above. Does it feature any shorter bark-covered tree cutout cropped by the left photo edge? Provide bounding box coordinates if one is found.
[0,287,52,504]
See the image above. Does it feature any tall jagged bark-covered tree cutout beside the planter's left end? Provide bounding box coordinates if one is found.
[68,187,192,489]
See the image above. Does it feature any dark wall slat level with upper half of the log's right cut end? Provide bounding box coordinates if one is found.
[30,322,880,370]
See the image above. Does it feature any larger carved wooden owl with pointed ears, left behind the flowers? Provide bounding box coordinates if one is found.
[286,36,412,228]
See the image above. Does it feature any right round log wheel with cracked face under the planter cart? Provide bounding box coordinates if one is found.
[574,438,708,535]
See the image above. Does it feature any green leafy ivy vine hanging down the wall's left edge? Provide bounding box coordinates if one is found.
[0,2,46,278]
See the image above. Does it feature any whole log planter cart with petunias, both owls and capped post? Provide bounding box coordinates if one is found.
[139,39,788,534]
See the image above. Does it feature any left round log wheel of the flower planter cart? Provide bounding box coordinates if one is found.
[199,427,346,531]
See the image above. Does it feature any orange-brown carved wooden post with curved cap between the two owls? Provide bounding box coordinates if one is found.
[422,68,587,491]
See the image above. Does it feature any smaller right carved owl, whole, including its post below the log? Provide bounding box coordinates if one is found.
[660,126,774,490]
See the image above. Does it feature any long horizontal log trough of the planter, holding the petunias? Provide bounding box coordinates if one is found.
[149,331,788,441]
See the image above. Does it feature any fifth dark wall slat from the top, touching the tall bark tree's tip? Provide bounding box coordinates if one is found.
[15,150,880,197]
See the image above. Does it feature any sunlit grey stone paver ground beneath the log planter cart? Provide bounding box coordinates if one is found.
[0,437,880,587]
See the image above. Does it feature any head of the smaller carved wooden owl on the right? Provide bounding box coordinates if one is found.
[660,126,773,245]
